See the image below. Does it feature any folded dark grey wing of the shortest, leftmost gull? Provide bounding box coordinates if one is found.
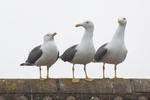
[26,45,42,64]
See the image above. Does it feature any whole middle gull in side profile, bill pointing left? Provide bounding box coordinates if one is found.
[60,21,95,83]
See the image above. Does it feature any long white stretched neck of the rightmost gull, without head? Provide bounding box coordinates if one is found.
[111,24,126,43]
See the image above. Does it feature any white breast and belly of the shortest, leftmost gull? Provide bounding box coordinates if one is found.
[35,43,58,67]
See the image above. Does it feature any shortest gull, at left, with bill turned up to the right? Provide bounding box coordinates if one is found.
[20,32,59,80]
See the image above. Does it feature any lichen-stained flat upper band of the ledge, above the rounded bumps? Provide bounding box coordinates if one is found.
[0,79,150,94]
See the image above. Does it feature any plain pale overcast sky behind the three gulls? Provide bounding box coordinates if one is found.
[0,0,150,78]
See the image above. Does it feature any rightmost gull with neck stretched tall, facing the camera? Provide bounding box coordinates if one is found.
[94,18,127,80]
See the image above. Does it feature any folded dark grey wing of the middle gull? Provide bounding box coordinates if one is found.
[60,45,77,62]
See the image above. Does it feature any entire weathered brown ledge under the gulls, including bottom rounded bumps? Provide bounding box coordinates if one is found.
[0,79,150,100]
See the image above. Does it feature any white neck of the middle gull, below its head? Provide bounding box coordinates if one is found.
[81,28,94,43]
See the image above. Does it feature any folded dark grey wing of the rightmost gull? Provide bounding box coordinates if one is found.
[94,43,107,62]
